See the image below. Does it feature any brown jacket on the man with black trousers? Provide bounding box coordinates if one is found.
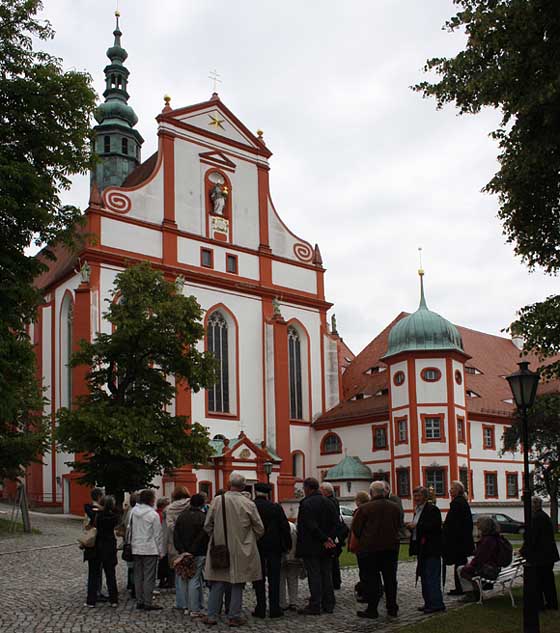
[352,498,401,553]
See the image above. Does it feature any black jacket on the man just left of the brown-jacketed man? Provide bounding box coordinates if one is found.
[296,491,340,558]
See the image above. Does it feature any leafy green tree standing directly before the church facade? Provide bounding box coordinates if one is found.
[58,263,215,500]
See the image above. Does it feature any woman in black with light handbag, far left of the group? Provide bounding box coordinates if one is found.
[84,496,119,608]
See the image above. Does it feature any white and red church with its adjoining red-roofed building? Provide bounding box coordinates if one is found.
[15,16,536,516]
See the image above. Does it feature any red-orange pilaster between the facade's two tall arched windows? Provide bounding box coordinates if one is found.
[272,314,295,501]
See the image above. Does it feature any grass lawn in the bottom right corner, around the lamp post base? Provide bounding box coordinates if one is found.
[399,575,560,633]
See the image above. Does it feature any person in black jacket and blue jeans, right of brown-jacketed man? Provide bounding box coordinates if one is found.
[406,486,445,614]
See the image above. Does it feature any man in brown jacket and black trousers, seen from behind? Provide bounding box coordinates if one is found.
[352,481,401,618]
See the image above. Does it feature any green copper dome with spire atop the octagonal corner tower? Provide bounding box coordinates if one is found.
[383,271,464,358]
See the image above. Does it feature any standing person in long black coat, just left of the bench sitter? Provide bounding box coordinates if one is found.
[442,481,474,596]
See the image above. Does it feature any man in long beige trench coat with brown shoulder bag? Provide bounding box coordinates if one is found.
[204,471,264,626]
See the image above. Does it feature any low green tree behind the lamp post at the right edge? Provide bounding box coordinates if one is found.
[503,393,560,527]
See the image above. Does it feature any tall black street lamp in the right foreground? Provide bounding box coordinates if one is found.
[506,361,540,633]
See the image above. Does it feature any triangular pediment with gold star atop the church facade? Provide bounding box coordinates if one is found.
[158,96,271,157]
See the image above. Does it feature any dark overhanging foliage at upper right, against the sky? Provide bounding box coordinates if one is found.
[414,0,560,376]
